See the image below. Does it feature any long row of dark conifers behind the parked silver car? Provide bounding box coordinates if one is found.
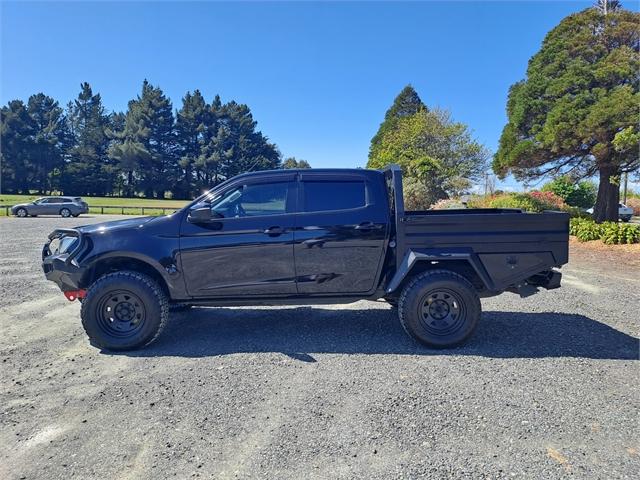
[0,80,282,198]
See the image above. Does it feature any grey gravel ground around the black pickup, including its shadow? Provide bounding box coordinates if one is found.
[0,217,640,479]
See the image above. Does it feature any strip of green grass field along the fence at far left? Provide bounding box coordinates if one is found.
[0,194,189,216]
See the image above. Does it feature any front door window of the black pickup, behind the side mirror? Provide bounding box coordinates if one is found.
[211,182,289,218]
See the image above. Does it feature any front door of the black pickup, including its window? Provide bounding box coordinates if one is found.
[180,174,297,298]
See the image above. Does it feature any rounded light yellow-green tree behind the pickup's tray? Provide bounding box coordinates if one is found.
[367,108,488,207]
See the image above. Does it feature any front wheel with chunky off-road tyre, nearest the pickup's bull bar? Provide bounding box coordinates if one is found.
[80,271,169,351]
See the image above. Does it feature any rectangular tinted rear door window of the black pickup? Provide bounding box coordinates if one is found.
[304,181,366,212]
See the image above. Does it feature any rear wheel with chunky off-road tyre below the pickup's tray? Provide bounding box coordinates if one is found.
[398,270,481,348]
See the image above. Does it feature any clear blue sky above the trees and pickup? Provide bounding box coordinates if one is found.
[0,1,616,190]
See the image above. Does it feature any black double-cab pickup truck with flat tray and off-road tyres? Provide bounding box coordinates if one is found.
[42,167,569,350]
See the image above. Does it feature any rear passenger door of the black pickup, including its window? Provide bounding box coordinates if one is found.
[294,172,388,295]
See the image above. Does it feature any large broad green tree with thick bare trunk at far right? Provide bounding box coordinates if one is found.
[493,2,640,222]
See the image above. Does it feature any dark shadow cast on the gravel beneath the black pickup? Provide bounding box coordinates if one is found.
[116,307,640,362]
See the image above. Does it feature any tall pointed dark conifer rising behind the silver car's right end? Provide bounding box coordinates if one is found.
[61,82,113,195]
